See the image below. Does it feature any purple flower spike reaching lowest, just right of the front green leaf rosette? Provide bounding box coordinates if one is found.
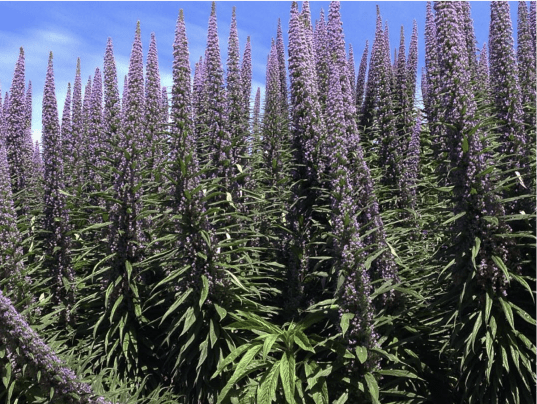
[326,63,377,349]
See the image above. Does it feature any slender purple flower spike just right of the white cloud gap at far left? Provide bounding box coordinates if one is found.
[42,52,75,322]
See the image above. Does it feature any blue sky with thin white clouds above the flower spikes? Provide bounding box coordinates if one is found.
[0,0,529,144]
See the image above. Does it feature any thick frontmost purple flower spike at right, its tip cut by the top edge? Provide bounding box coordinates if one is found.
[435,3,517,294]
